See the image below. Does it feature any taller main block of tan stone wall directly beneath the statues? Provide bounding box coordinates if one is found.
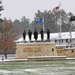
[16,42,57,59]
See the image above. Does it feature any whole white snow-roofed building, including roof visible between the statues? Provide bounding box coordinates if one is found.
[16,32,75,47]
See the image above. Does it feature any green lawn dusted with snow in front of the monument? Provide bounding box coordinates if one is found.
[0,60,75,75]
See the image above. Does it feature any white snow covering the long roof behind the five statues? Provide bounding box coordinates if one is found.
[15,32,75,42]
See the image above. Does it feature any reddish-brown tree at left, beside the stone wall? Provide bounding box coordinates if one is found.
[0,19,17,58]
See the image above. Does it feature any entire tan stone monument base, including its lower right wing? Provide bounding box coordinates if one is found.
[15,42,75,60]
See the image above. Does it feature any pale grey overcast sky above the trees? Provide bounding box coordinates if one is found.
[1,0,75,21]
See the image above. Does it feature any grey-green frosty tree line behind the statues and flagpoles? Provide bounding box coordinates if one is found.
[13,9,74,37]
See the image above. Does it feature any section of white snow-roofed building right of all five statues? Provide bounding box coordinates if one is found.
[50,32,75,47]
